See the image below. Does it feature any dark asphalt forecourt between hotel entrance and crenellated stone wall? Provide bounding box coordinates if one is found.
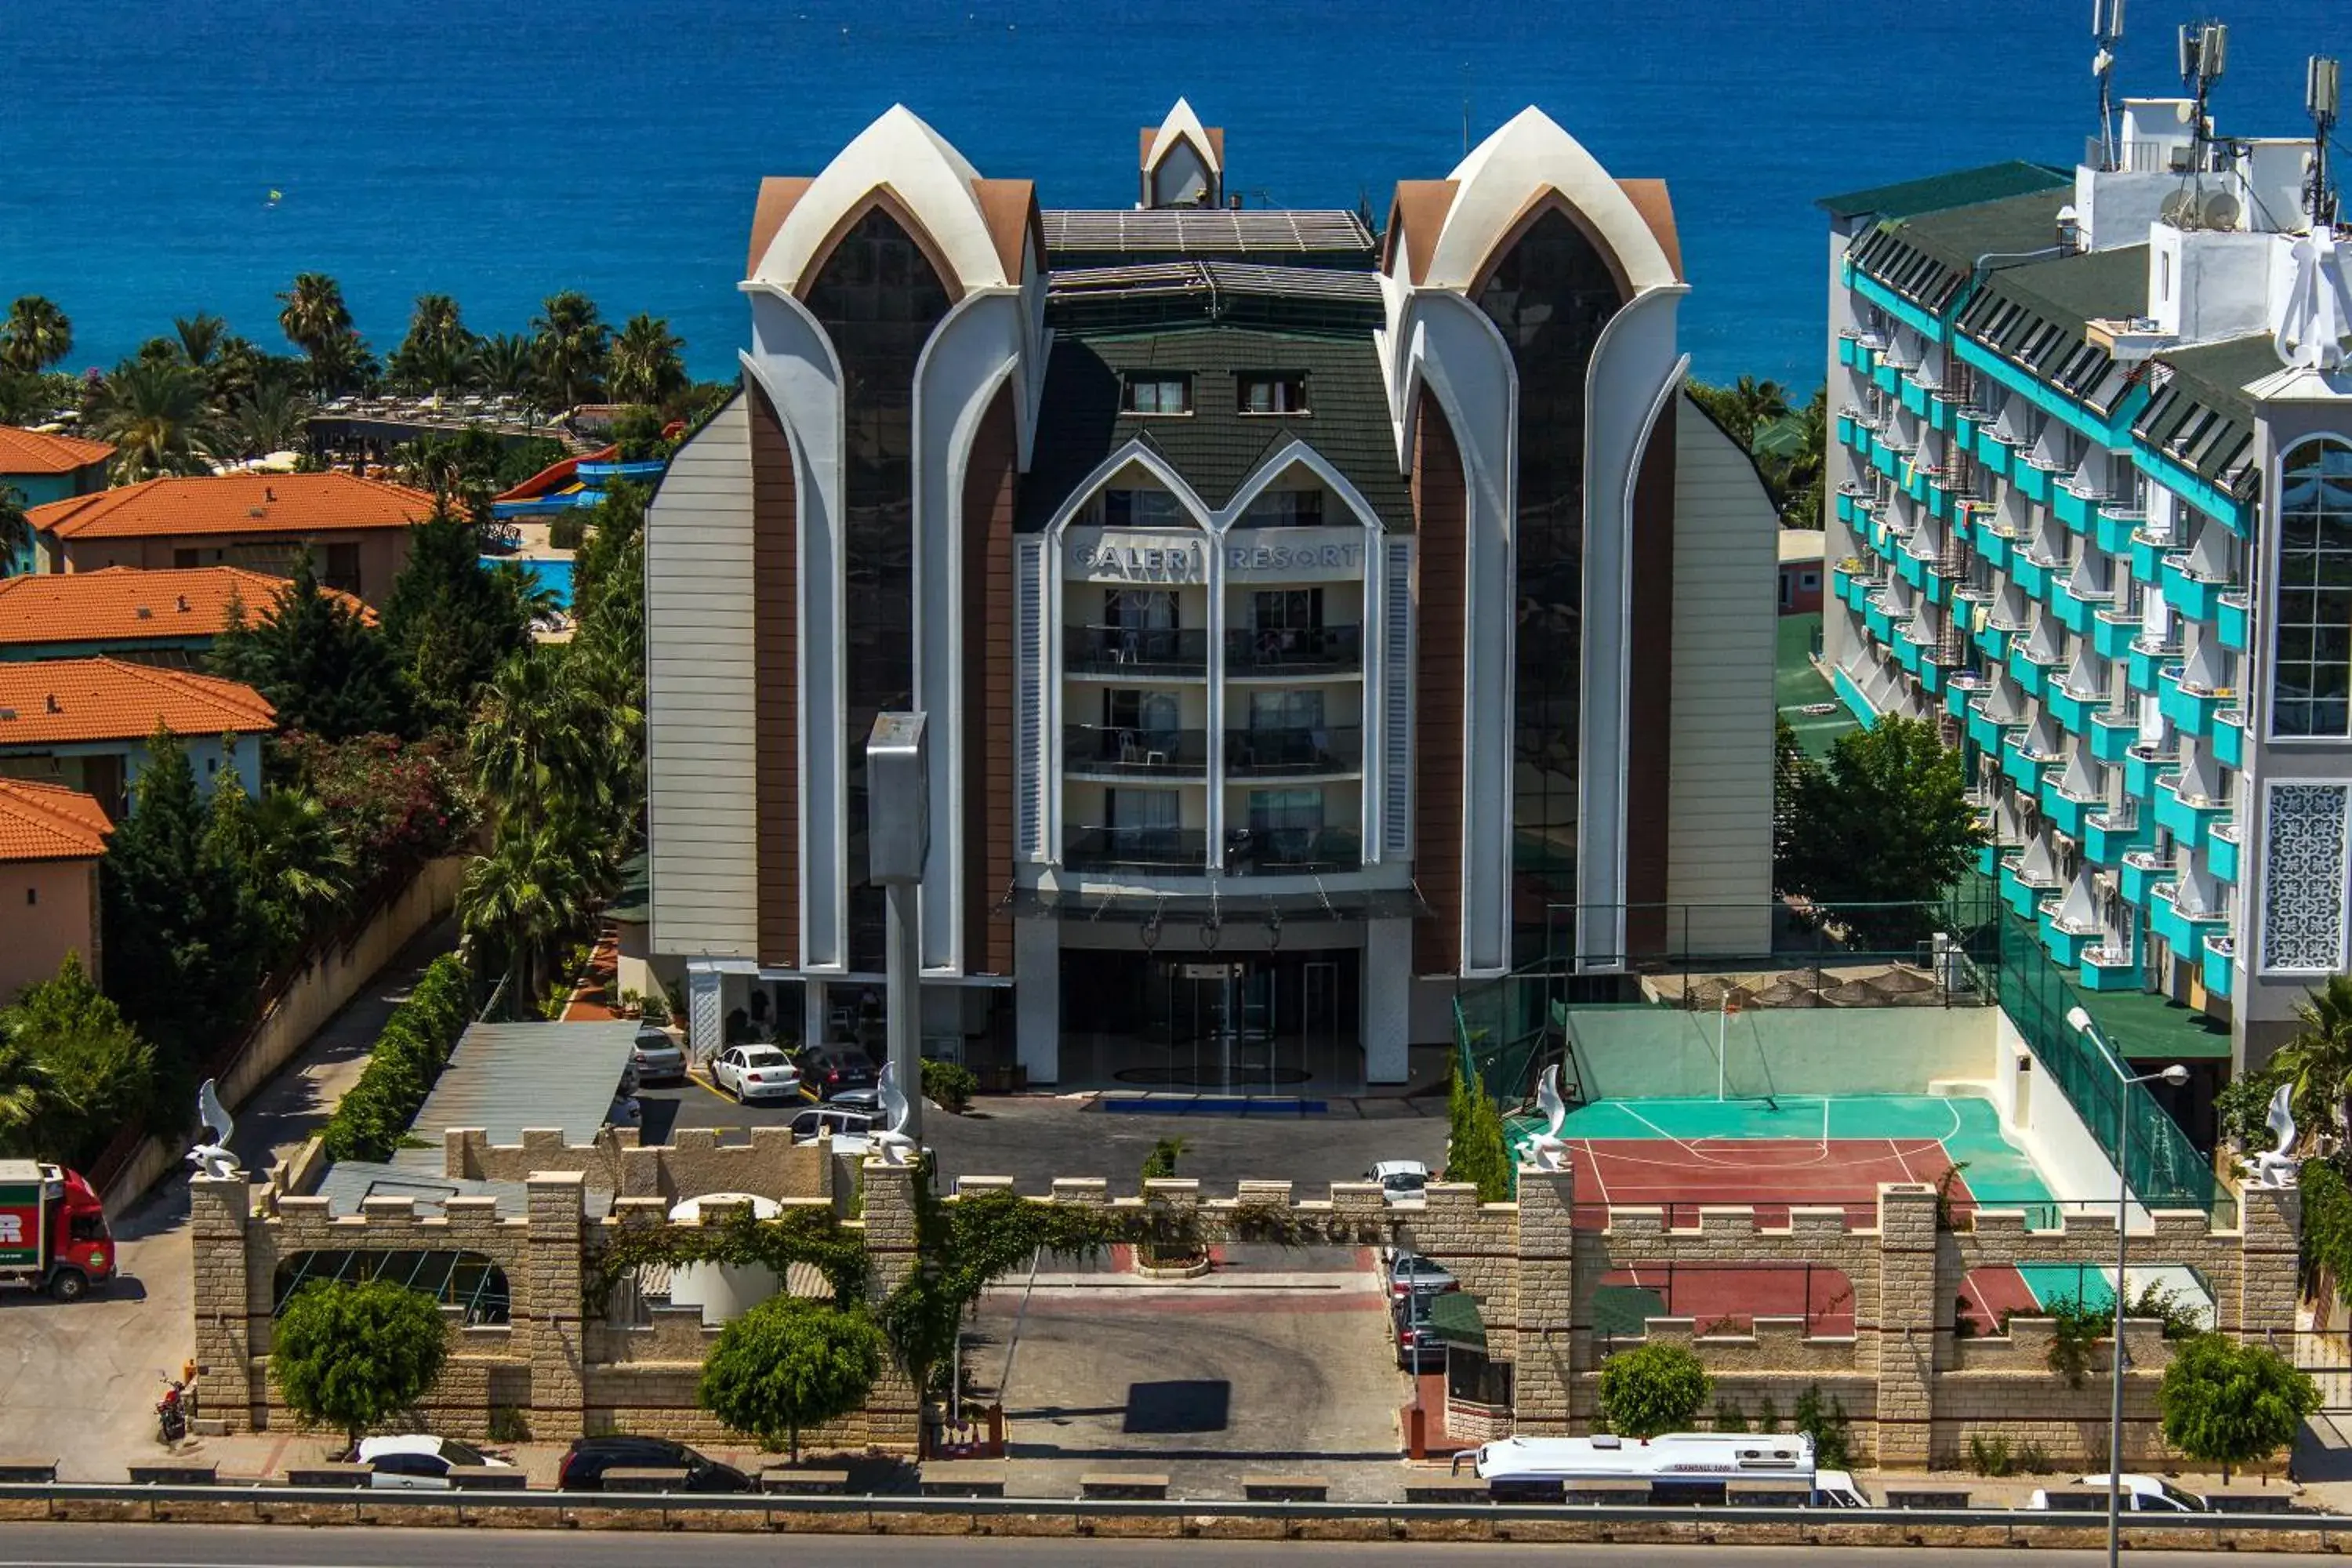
[637,1081,1446,1196]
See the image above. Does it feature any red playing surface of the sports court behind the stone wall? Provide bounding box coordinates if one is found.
[1569,1138,2037,1335]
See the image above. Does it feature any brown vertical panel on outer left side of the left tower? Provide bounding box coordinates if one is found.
[748,386,800,968]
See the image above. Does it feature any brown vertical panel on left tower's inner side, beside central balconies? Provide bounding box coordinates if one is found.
[960,386,1021,975]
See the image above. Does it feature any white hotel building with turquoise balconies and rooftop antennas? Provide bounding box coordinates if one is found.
[1823,99,2352,1065]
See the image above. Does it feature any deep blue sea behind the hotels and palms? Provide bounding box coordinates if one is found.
[0,0,2352,388]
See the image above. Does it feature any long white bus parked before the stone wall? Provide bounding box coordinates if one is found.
[1454,1432,1870,1509]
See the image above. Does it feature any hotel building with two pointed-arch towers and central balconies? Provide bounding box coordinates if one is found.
[647,103,1776,1091]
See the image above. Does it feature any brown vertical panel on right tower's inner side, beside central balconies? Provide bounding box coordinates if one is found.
[1414,395,1470,975]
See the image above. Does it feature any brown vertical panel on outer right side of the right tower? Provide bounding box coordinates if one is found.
[1625,397,1679,956]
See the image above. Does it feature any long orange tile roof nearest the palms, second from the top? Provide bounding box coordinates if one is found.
[26,473,433,539]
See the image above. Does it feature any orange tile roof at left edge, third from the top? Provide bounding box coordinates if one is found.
[0,567,376,644]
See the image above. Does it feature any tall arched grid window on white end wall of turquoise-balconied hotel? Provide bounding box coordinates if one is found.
[2267,440,2352,736]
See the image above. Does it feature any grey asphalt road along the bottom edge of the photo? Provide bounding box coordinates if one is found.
[0,1523,2340,1568]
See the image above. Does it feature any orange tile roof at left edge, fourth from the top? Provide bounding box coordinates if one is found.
[0,659,278,748]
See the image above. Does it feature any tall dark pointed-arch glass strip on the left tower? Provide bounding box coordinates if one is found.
[807,207,948,973]
